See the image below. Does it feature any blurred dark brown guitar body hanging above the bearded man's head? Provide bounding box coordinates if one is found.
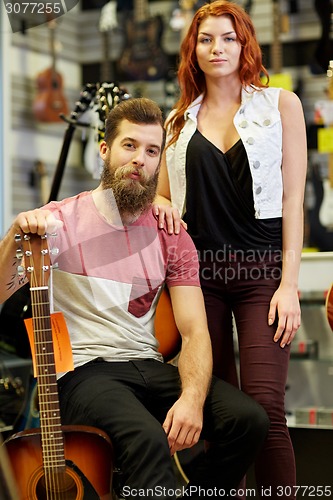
[119,16,168,81]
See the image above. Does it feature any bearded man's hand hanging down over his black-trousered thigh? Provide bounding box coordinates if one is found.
[163,396,203,456]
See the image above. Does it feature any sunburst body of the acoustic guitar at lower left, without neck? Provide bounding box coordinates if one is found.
[5,426,113,500]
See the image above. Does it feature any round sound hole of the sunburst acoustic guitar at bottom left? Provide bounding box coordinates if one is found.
[36,468,82,500]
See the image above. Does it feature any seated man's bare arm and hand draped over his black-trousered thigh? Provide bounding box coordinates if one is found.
[163,286,212,455]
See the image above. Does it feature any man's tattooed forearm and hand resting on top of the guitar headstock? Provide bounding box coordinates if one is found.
[0,208,62,304]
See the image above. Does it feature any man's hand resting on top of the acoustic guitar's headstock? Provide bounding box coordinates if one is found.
[13,208,63,236]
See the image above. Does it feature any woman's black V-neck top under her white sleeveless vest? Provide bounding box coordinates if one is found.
[184,130,282,252]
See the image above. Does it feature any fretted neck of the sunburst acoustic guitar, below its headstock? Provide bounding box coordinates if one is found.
[30,286,65,472]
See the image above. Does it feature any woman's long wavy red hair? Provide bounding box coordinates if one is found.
[167,0,269,144]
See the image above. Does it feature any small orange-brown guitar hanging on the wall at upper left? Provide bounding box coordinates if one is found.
[33,20,68,122]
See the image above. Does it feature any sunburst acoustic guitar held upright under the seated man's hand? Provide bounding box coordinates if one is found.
[5,234,113,500]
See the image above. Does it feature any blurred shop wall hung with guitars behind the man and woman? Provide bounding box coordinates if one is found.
[4,0,333,251]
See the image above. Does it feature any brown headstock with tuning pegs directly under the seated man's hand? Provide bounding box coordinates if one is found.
[15,233,51,288]
